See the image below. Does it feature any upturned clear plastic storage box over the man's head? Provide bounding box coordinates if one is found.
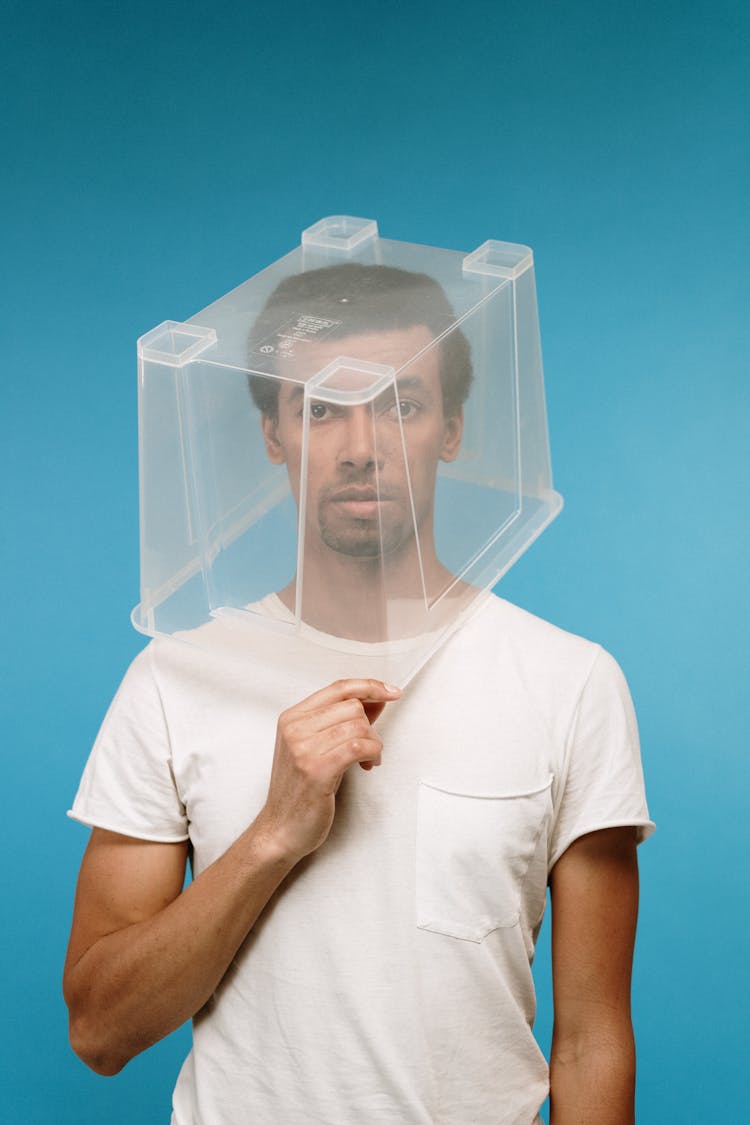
[133,216,561,685]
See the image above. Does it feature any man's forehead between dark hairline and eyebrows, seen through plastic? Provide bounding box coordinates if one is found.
[278,324,439,390]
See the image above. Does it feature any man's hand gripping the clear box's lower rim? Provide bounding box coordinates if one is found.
[256,680,400,862]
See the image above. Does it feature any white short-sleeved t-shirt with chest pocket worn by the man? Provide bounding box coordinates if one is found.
[71,596,653,1125]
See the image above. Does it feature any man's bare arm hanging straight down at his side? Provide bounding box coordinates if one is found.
[550,828,638,1125]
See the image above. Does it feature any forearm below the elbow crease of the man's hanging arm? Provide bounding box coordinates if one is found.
[550,1024,635,1125]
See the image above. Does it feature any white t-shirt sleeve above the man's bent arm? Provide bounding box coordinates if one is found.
[67,645,188,843]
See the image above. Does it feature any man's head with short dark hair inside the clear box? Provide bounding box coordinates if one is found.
[251,263,471,571]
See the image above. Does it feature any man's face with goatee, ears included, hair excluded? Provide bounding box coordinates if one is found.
[263,325,462,558]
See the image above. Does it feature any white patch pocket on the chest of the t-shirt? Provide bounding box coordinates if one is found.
[416,776,552,942]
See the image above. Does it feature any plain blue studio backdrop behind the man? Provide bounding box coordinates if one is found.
[0,0,750,1125]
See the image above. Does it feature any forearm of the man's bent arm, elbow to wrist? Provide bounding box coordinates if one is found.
[65,821,293,1074]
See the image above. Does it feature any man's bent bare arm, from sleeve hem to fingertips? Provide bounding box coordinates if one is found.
[63,680,399,1074]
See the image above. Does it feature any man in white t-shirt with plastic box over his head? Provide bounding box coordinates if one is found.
[64,266,652,1125]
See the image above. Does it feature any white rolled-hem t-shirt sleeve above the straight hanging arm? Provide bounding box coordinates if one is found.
[549,649,656,870]
